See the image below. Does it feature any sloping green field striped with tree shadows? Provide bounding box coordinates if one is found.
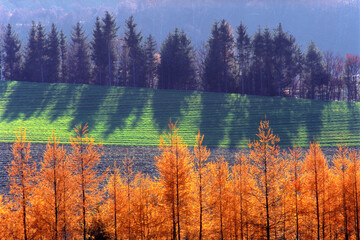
[0,82,360,147]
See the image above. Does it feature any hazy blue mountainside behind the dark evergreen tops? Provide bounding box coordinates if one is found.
[0,0,360,55]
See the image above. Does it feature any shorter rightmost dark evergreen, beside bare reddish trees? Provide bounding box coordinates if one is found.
[305,42,325,99]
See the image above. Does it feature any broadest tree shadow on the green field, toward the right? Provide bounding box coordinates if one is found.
[228,95,324,147]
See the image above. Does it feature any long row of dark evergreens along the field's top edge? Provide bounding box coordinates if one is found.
[2,12,360,101]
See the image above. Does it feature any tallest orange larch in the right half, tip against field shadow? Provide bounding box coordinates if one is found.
[249,120,284,239]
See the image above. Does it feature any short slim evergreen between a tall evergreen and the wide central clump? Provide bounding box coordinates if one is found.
[144,34,158,88]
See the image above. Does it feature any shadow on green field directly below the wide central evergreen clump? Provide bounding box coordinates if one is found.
[152,90,194,134]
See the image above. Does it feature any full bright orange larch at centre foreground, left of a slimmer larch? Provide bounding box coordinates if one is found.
[155,121,193,240]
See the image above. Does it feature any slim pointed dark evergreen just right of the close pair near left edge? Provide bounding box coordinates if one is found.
[45,24,60,83]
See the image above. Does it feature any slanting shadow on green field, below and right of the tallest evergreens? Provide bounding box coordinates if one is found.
[104,88,152,138]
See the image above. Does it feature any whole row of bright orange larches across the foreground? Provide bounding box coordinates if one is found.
[0,121,360,239]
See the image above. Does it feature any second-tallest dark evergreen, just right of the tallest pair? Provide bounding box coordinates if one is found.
[123,16,146,87]
